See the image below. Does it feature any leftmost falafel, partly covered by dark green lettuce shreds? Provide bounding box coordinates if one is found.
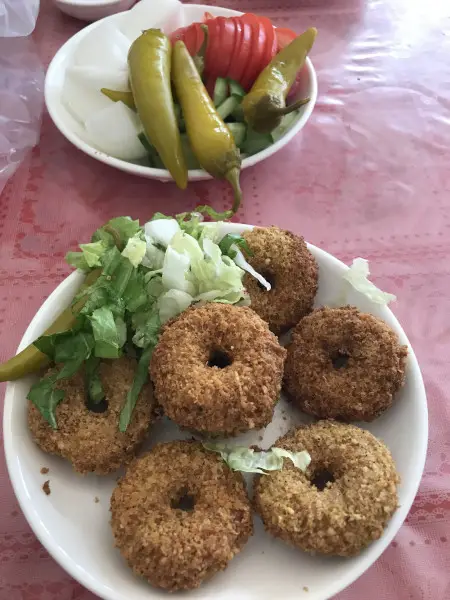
[28,357,156,475]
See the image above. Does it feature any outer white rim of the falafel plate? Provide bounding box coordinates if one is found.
[3,223,428,600]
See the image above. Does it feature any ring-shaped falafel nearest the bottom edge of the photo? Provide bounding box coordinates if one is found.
[111,441,253,591]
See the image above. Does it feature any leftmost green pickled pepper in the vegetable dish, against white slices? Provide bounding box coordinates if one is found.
[128,29,188,189]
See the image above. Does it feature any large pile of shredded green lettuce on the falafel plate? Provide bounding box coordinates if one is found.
[28,213,269,431]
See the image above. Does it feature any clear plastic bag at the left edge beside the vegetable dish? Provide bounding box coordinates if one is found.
[0,0,44,194]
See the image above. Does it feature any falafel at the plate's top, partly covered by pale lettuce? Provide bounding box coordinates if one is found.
[243,227,319,335]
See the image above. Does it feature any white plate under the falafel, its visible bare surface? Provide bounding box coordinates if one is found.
[3,224,428,600]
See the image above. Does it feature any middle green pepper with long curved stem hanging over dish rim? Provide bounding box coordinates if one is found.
[172,41,242,219]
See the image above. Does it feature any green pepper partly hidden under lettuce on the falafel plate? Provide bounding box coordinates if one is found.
[0,269,101,381]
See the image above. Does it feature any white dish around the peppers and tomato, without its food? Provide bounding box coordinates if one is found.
[45,0,317,181]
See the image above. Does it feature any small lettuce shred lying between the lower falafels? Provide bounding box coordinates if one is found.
[203,442,311,474]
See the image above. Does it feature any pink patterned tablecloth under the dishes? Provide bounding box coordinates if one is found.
[0,0,450,600]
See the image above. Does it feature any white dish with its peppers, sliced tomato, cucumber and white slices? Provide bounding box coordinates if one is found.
[45,0,317,209]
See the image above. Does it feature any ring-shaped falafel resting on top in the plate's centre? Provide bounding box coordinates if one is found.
[150,303,286,434]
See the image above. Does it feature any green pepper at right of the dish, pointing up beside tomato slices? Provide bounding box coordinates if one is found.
[242,27,317,133]
